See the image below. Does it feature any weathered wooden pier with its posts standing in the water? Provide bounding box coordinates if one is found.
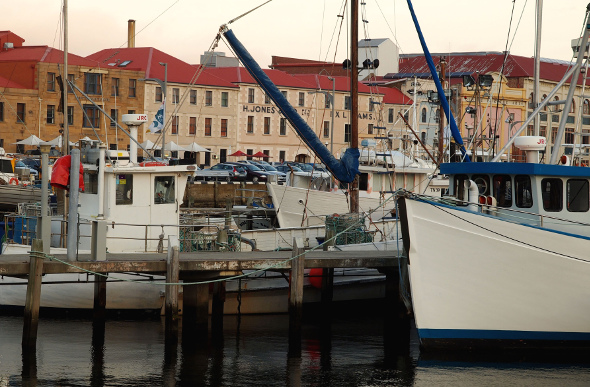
[0,238,408,347]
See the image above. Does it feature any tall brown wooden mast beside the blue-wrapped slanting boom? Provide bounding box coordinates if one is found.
[350,0,359,213]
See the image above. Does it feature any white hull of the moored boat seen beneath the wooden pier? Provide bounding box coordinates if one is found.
[0,269,385,314]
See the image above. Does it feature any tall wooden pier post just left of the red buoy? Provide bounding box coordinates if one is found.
[289,237,305,346]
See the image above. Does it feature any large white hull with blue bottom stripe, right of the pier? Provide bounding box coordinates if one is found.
[402,199,590,346]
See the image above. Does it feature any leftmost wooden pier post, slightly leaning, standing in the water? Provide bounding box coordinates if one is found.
[22,239,43,348]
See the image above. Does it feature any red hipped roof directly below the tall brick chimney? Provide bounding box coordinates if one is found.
[86,47,236,87]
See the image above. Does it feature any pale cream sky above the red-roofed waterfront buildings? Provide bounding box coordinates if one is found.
[5,0,588,68]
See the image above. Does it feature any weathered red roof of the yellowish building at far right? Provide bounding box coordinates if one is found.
[396,52,590,84]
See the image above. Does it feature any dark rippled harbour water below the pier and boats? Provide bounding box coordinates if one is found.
[0,315,590,387]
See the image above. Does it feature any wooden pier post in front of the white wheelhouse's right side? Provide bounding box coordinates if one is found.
[165,235,180,335]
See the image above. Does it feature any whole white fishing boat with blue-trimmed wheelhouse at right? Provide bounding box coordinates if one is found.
[399,2,590,349]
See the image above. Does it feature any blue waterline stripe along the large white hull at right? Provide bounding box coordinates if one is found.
[418,329,590,341]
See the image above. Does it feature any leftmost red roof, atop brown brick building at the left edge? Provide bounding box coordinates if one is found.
[0,46,94,67]
